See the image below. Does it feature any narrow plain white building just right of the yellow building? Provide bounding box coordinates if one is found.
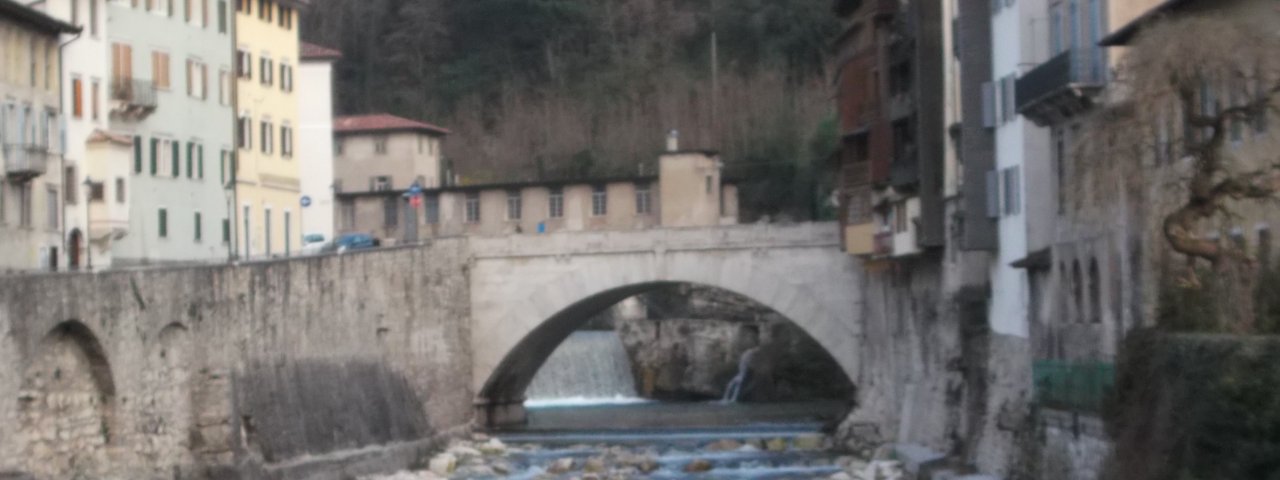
[298,42,342,241]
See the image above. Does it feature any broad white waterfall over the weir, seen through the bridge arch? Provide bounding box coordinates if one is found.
[526,330,639,406]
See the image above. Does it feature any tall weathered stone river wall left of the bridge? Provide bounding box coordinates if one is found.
[0,241,472,479]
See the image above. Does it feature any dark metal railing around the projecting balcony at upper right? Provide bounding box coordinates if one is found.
[1015,46,1107,111]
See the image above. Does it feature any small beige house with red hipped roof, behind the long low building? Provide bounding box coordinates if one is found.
[333,114,449,192]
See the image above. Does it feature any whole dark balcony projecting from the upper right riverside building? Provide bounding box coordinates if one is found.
[1016,47,1107,127]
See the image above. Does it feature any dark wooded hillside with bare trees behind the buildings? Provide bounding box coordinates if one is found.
[302,0,840,221]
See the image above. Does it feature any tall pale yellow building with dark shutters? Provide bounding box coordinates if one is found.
[234,0,306,259]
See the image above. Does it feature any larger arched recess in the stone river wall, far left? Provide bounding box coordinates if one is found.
[18,320,122,479]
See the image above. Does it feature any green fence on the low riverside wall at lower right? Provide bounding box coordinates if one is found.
[1032,360,1116,413]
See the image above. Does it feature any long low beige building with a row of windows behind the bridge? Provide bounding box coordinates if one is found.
[335,151,739,244]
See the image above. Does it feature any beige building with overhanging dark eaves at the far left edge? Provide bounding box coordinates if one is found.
[0,0,77,270]
